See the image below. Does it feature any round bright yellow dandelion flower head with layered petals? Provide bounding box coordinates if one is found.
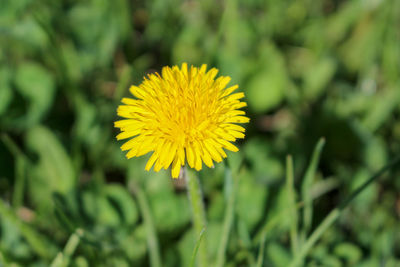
[115,63,249,178]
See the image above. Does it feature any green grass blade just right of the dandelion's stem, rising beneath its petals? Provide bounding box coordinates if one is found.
[215,167,236,267]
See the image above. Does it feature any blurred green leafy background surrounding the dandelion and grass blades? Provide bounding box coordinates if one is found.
[0,0,400,267]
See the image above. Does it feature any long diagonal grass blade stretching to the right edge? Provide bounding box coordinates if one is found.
[289,156,400,267]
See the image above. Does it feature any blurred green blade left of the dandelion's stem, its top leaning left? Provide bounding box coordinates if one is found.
[130,182,161,267]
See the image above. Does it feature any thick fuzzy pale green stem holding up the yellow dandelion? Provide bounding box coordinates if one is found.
[183,167,209,267]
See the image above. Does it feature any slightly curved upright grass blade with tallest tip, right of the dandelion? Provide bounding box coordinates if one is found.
[301,138,325,239]
